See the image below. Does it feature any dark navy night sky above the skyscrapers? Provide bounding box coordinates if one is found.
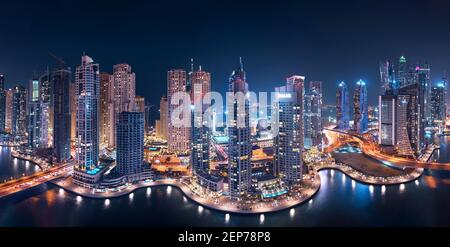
[0,0,450,117]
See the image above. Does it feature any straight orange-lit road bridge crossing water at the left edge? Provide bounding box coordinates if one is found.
[0,162,73,198]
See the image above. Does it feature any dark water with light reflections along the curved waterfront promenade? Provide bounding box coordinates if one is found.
[0,145,450,226]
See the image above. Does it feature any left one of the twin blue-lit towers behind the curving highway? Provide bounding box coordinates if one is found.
[336,81,350,130]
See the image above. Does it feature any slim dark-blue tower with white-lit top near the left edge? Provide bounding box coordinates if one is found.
[28,78,42,148]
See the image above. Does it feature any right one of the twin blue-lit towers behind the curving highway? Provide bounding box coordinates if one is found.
[353,80,368,133]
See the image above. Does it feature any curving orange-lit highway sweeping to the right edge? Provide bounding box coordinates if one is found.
[324,129,450,170]
